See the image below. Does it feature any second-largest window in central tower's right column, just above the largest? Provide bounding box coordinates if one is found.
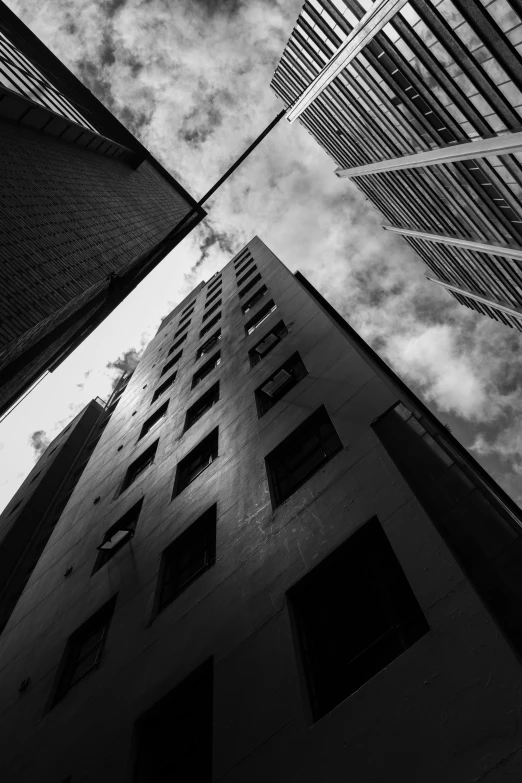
[265,405,343,508]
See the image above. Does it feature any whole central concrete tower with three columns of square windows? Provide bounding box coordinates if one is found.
[0,237,522,783]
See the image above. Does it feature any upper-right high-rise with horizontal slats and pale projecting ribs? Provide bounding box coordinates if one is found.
[272,0,522,329]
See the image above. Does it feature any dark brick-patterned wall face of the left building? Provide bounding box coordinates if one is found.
[0,120,194,410]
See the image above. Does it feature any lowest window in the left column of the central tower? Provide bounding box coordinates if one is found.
[51,596,116,706]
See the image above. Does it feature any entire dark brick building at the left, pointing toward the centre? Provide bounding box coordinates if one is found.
[0,2,205,420]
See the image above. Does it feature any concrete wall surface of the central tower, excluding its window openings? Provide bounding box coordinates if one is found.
[0,237,522,783]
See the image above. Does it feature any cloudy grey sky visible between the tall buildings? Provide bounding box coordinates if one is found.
[0,0,522,508]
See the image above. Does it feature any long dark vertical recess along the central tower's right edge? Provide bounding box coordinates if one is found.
[372,403,522,659]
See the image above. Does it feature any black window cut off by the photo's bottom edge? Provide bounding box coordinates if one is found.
[133,659,213,783]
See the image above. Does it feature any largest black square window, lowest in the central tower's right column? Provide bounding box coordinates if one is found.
[288,518,429,721]
